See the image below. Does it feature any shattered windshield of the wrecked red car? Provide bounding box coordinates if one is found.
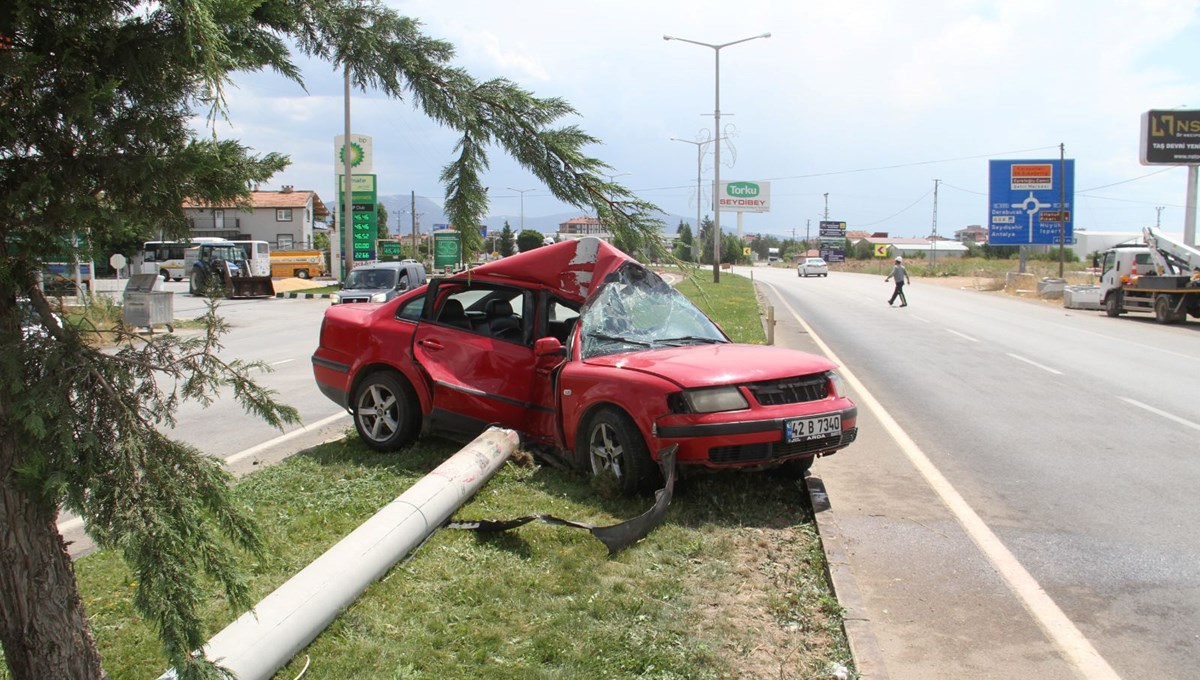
[580,263,728,359]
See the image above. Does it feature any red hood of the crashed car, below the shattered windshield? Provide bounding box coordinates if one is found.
[584,343,836,389]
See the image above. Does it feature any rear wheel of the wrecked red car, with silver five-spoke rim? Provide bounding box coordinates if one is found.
[352,371,420,452]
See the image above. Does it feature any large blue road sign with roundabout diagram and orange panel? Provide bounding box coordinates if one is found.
[988,158,1075,246]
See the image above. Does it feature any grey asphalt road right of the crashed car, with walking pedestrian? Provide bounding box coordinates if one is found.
[736,267,1200,679]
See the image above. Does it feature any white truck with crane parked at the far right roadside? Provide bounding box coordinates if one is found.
[1100,227,1200,324]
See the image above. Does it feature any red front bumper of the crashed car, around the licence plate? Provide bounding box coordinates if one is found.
[654,405,858,468]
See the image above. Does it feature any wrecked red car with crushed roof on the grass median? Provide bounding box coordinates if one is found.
[312,239,858,494]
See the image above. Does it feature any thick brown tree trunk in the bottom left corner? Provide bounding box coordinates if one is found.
[0,431,106,680]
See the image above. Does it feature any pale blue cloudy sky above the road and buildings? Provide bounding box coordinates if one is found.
[208,0,1200,237]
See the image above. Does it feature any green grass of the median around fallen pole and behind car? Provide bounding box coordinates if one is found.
[28,273,851,680]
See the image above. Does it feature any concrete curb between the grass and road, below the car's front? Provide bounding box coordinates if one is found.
[804,475,888,680]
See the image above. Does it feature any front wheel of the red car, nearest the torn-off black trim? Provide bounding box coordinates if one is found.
[580,408,662,497]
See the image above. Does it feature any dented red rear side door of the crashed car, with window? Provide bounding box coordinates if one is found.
[413,281,534,438]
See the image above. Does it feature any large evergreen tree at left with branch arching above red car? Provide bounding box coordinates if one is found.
[0,0,659,680]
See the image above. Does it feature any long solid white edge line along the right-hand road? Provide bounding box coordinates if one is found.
[763,283,1120,680]
